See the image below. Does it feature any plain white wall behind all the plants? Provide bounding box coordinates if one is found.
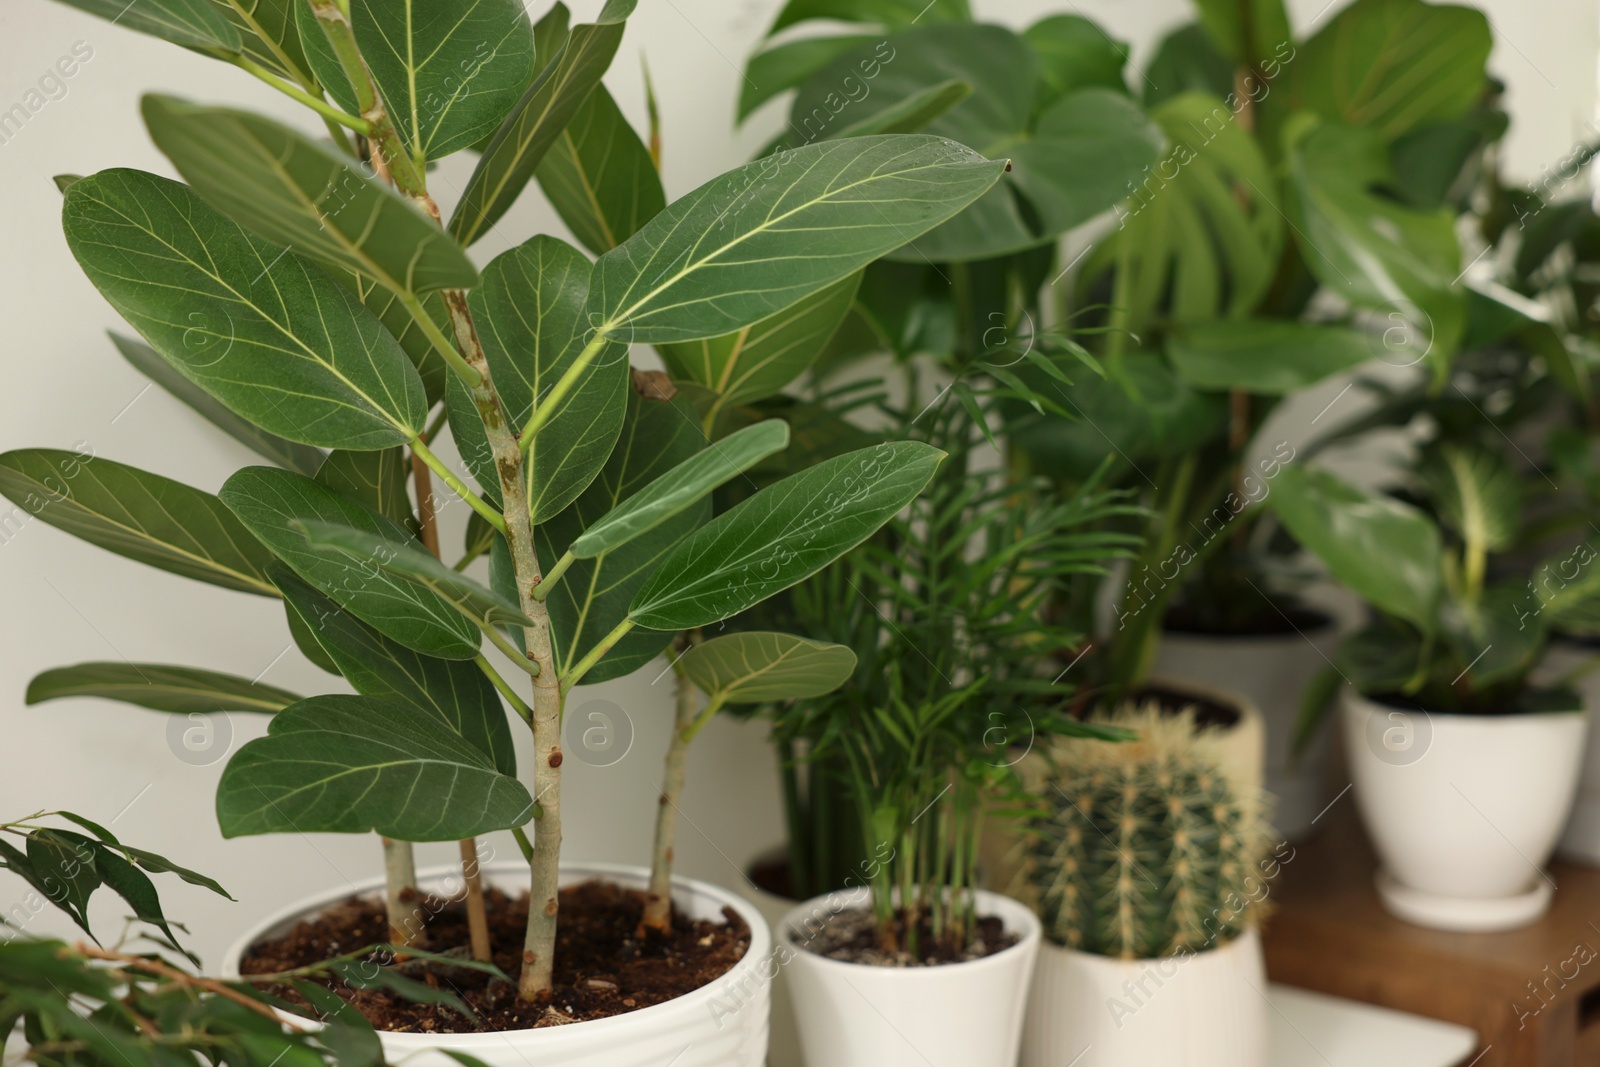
[0,0,1597,961]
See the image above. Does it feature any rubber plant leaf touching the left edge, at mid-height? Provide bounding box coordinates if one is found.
[0,448,277,597]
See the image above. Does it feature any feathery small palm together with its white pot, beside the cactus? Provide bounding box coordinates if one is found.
[758,371,1130,1065]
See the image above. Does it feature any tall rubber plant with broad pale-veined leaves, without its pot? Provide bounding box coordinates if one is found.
[0,0,1006,1000]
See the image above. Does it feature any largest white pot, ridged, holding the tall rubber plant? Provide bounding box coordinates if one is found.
[222,862,773,1067]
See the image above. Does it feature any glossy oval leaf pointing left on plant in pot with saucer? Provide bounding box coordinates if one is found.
[1267,467,1443,630]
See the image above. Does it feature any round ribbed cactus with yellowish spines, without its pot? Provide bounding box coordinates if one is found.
[1022,704,1270,960]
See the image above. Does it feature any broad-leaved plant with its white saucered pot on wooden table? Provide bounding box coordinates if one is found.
[1270,454,1587,929]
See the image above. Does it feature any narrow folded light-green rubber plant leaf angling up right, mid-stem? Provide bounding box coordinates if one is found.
[568,419,789,560]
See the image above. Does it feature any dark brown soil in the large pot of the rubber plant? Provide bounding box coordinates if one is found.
[238,881,750,1033]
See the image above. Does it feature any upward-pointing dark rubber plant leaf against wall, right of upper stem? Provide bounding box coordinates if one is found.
[536,85,667,256]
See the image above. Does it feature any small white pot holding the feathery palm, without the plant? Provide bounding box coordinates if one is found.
[776,888,1040,1067]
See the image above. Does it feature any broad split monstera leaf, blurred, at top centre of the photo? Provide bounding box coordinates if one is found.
[784,26,1160,261]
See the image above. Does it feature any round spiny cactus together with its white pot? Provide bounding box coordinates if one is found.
[1019,702,1273,1067]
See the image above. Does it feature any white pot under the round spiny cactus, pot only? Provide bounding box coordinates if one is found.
[1021,929,1267,1067]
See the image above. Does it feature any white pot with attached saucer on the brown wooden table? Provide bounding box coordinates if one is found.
[1342,688,1589,931]
